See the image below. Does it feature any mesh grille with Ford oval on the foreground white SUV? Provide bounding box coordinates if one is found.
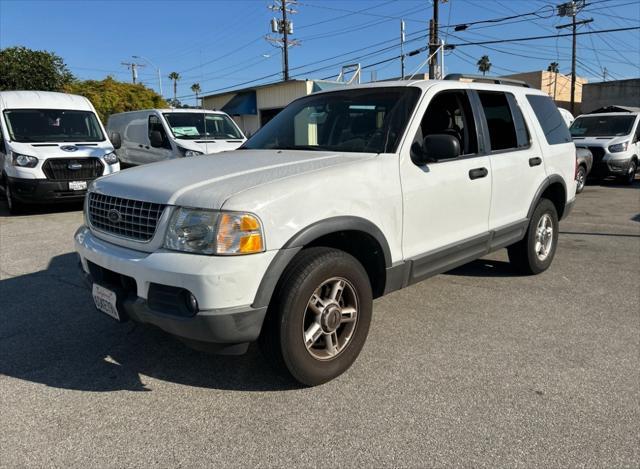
[88,192,165,241]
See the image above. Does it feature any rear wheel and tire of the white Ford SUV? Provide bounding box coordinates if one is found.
[507,199,558,275]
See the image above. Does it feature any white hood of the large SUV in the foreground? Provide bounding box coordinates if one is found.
[90,150,374,209]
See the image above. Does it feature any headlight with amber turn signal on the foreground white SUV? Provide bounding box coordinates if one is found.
[164,208,264,255]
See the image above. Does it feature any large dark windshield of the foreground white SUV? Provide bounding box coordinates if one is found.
[242,87,420,153]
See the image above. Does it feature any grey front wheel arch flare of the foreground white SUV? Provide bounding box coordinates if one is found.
[252,216,391,307]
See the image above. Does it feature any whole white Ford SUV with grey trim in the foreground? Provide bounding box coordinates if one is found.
[75,79,576,385]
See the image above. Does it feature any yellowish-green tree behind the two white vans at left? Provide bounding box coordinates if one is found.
[65,77,167,123]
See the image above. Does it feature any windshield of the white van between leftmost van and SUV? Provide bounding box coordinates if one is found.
[164,112,244,140]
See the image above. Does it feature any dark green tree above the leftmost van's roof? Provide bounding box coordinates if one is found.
[0,47,73,91]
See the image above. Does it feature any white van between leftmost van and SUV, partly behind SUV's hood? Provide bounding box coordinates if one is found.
[107,109,246,165]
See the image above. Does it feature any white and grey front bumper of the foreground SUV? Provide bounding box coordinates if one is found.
[75,227,275,348]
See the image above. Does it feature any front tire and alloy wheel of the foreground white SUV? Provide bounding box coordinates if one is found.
[260,247,373,386]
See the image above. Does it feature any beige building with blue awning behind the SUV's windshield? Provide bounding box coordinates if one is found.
[202,80,344,136]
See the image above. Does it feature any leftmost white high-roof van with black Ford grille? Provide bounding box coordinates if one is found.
[0,91,120,213]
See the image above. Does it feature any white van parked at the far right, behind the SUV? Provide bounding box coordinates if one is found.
[571,108,640,184]
